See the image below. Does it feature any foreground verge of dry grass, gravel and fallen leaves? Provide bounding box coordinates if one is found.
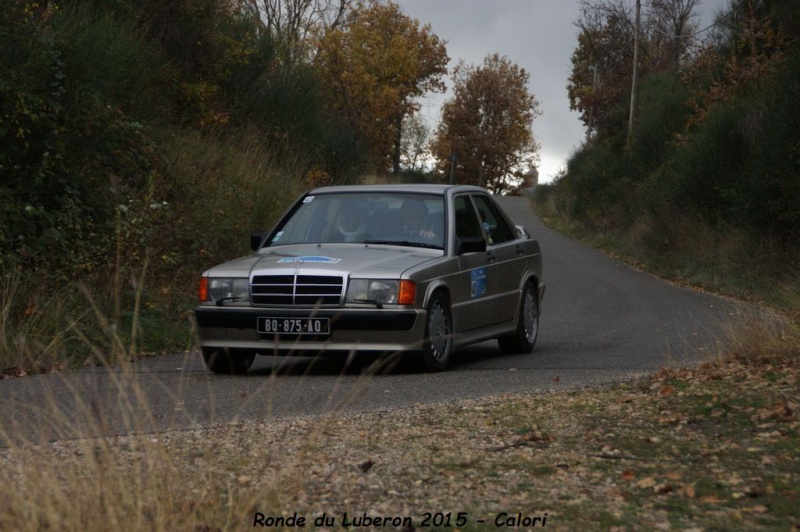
[0,312,800,531]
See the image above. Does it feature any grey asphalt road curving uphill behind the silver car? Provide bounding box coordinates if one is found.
[0,198,737,445]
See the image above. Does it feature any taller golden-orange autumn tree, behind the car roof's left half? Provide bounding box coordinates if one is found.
[316,2,449,173]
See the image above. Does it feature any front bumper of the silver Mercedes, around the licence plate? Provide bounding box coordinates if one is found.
[195,305,426,355]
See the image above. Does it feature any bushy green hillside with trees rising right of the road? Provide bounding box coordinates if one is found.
[536,0,800,318]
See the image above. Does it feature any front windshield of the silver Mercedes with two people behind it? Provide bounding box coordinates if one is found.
[266,192,444,249]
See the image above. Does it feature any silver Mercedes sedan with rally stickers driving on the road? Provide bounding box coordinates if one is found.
[195,185,545,373]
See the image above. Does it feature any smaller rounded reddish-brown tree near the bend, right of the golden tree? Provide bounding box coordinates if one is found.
[431,54,540,194]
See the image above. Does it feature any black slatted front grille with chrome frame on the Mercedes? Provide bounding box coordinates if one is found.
[250,275,344,306]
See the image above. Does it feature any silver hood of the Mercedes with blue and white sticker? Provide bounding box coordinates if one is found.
[207,244,443,279]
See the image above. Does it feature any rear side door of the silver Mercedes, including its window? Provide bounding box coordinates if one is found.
[472,194,525,323]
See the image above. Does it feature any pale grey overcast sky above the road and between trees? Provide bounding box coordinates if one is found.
[394,0,728,183]
